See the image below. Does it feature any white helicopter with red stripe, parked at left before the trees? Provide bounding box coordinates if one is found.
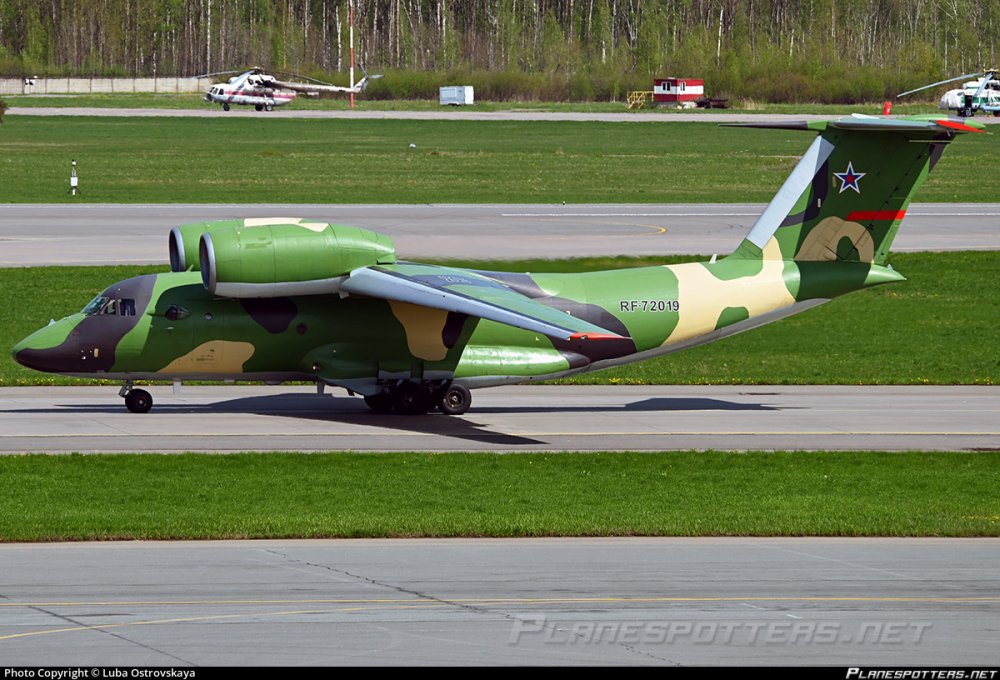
[199,66,382,111]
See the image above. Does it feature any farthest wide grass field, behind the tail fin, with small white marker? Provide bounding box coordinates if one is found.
[0,116,1000,204]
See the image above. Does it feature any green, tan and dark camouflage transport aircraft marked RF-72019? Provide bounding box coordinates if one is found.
[13,116,983,414]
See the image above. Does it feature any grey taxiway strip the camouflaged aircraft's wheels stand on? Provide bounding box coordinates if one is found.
[0,385,1000,453]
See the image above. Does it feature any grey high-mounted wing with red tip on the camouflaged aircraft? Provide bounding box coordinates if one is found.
[340,263,623,340]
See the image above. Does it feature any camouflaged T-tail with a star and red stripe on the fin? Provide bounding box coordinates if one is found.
[730,115,984,266]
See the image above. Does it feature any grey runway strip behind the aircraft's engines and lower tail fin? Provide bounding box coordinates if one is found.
[0,203,1000,267]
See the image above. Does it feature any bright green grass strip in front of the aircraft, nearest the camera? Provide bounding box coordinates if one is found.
[0,452,1000,541]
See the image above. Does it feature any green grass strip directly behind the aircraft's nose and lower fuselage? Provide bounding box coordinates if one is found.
[0,252,1000,385]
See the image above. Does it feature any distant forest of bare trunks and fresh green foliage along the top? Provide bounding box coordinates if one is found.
[0,0,1000,102]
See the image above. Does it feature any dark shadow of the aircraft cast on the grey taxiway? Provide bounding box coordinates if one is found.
[22,394,785,446]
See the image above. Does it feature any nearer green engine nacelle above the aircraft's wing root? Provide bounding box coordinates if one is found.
[199,220,396,298]
